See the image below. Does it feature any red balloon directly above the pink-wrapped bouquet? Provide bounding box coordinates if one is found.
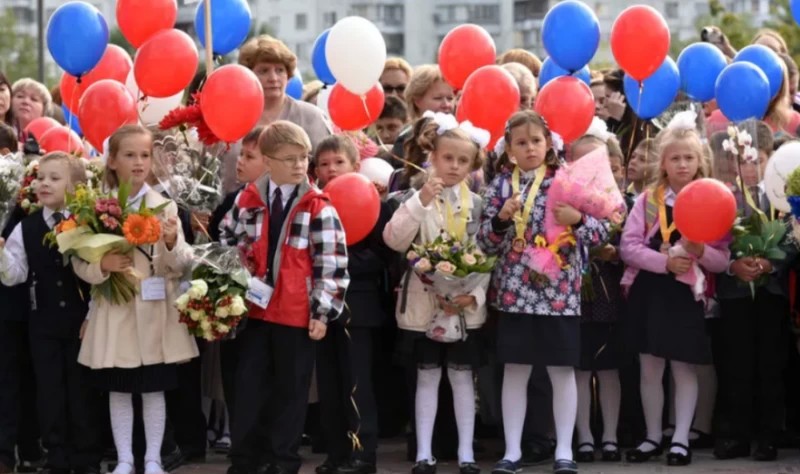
[533,76,594,143]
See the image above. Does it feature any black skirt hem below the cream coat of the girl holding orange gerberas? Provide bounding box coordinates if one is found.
[89,364,178,393]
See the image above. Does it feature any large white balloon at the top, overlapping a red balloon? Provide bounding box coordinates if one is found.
[325,16,386,95]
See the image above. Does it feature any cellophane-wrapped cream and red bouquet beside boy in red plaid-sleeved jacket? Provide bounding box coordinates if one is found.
[175,243,250,341]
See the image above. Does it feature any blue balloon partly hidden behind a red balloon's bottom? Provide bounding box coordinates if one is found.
[623,56,681,120]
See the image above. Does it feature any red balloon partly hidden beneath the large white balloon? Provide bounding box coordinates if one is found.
[328,84,385,131]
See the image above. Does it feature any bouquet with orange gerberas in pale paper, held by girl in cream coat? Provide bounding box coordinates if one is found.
[47,183,168,304]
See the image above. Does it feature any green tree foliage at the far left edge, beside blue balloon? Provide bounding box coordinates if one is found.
[0,8,39,82]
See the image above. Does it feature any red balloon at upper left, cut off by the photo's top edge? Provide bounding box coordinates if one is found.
[117,0,178,48]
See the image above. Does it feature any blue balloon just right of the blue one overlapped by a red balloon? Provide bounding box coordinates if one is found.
[678,43,728,102]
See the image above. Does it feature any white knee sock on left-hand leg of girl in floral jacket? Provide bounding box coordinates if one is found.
[501,364,532,462]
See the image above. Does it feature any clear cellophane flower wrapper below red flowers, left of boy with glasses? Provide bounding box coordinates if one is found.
[153,134,225,214]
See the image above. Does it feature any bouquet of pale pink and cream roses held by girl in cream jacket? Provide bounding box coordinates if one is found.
[406,232,497,342]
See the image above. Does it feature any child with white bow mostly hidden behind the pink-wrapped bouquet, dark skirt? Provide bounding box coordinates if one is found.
[573,134,624,462]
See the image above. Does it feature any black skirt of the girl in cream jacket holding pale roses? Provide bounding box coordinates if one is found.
[395,329,486,370]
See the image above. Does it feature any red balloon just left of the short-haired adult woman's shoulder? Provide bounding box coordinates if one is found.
[200,64,264,142]
